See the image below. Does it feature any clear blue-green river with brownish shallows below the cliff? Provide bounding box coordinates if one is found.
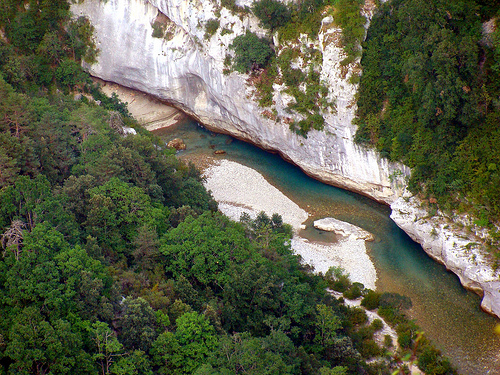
[155,122,500,375]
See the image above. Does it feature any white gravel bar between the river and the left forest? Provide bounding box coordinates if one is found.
[204,159,377,289]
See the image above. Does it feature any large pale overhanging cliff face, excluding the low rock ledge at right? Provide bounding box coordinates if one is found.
[72,0,408,204]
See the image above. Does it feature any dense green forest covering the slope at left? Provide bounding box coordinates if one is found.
[0,1,458,375]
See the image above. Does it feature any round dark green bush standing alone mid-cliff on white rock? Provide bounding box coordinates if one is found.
[231,30,274,73]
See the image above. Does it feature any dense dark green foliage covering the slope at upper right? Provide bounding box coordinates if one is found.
[356,0,500,232]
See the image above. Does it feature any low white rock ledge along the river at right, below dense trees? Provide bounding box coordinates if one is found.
[391,197,500,318]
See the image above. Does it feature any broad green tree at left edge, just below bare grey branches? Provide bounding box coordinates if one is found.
[0,224,110,319]
